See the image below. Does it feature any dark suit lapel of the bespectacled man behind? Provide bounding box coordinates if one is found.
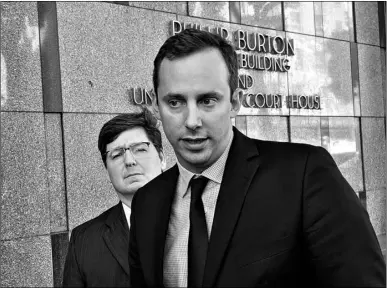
[102,202,130,276]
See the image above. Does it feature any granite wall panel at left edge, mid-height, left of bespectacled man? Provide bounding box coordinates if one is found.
[1,112,50,240]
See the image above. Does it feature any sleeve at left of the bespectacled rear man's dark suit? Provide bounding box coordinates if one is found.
[63,228,86,287]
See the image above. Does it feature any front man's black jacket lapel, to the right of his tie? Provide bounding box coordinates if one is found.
[203,129,259,287]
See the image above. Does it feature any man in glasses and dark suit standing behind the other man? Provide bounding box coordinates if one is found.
[63,110,165,287]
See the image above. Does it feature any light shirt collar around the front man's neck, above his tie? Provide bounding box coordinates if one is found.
[177,130,234,197]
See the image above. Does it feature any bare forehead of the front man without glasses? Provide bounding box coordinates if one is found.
[158,48,229,94]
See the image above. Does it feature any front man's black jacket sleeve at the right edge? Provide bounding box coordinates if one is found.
[303,147,386,287]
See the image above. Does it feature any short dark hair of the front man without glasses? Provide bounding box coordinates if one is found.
[153,28,238,97]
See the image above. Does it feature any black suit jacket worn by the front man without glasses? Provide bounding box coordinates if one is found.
[129,128,386,287]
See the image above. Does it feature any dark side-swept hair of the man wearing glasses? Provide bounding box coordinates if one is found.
[98,108,163,167]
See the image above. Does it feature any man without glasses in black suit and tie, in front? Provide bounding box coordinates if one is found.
[129,29,386,287]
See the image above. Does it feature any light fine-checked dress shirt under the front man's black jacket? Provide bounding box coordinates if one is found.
[163,132,234,287]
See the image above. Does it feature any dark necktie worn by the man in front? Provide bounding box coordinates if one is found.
[188,177,208,287]
